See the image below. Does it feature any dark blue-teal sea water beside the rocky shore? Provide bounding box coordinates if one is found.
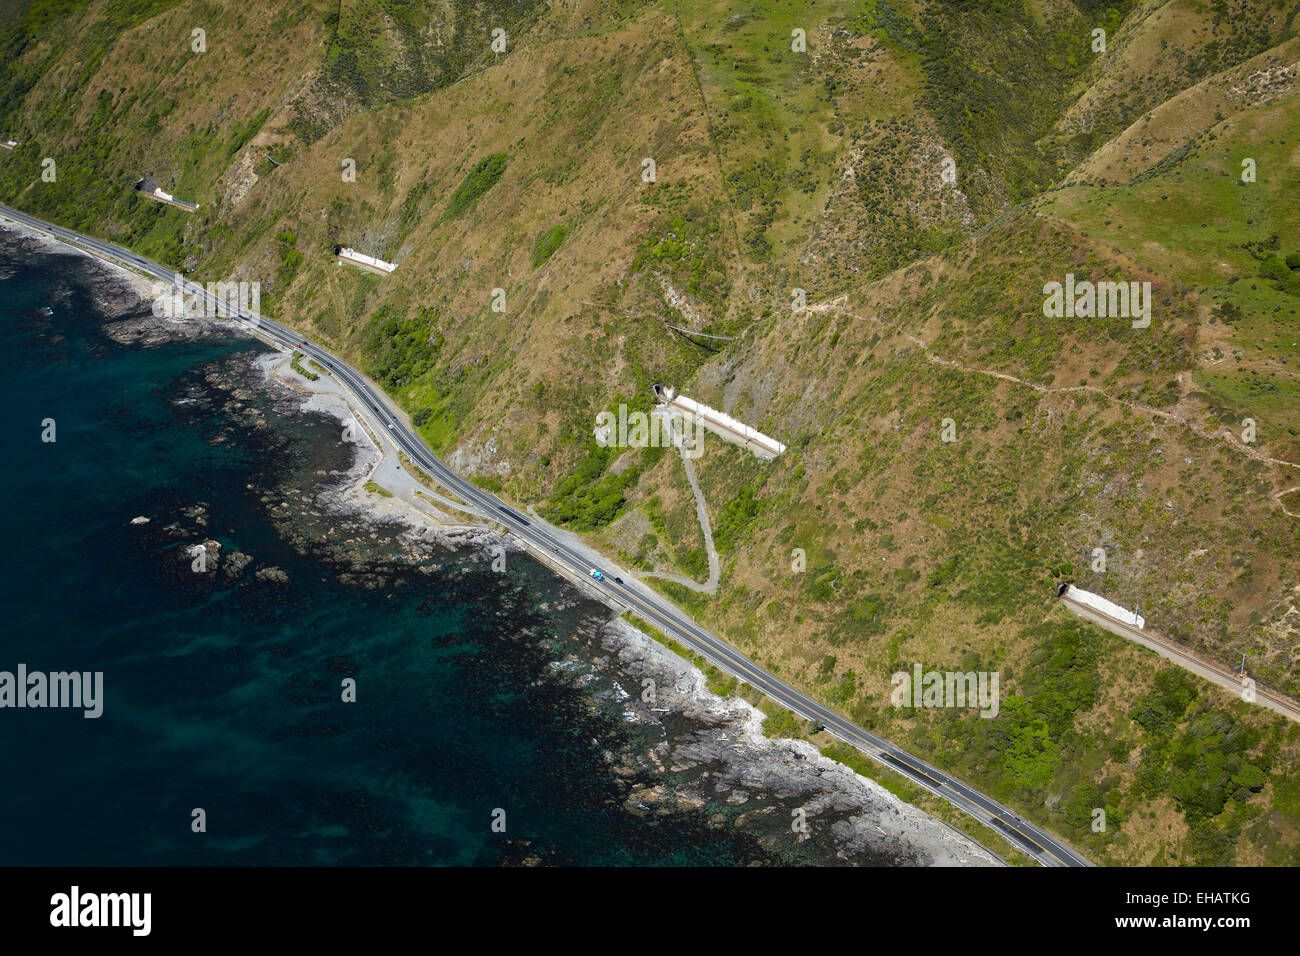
[0,239,768,865]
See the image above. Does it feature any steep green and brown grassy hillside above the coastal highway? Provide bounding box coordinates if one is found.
[0,0,1300,864]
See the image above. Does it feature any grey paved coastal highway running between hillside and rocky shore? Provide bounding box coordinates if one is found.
[0,206,1091,866]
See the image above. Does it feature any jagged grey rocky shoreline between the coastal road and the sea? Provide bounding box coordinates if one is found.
[0,222,1001,866]
